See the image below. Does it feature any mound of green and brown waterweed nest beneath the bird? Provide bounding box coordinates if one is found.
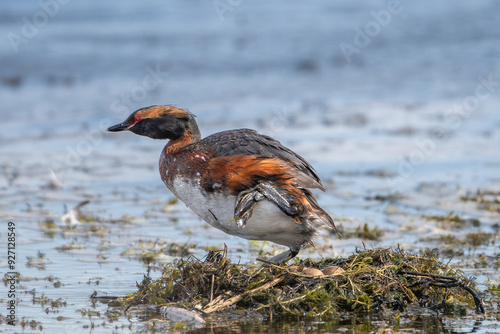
[118,248,484,317]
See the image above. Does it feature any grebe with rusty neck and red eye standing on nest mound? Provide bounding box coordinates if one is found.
[108,105,335,263]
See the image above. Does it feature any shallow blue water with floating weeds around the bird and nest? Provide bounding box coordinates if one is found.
[0,0,500,333]
